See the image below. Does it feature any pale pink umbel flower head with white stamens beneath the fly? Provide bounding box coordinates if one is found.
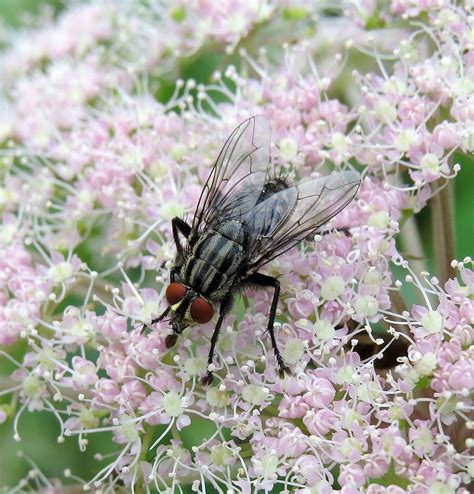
[0,0,474,494]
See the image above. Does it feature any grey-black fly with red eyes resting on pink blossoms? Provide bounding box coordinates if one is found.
[151,115,360,384]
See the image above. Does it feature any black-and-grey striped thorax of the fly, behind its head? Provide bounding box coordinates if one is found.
[181,221,244,298]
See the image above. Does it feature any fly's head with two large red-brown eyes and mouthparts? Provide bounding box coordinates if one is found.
[165,282,214,348]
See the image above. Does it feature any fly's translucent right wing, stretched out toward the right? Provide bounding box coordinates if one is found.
[245,171,360,270]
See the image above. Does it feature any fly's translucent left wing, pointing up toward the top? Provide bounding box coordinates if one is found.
[192,115,271,233]
